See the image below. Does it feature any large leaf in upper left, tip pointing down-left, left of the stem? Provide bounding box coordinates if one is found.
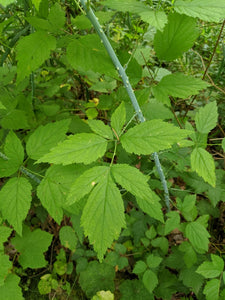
[17,31,56,83]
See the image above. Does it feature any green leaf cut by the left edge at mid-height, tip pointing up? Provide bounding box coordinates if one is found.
[0,131,24,177]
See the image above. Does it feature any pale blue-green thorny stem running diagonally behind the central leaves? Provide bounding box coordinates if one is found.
[80,0,170,211]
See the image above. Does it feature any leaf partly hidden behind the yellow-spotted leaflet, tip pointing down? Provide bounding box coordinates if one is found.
[37,165,86,224]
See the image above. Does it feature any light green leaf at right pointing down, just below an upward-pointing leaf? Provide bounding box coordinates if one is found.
[191,148,216,187]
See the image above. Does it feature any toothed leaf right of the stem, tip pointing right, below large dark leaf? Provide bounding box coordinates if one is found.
[152,73,208,106]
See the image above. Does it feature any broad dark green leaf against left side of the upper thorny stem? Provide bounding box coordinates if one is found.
[67,34,117,77]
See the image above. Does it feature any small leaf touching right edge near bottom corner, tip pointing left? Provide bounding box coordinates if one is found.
[196,254,224,278]
